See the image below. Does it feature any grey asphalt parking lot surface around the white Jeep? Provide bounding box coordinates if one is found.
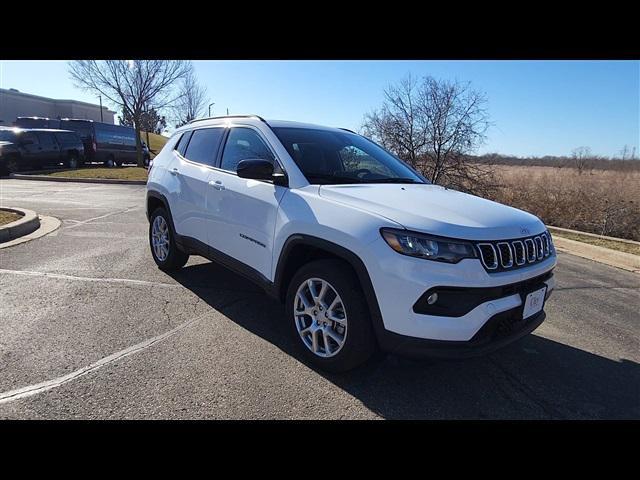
[0,179,640,419]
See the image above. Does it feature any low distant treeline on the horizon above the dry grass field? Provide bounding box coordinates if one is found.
[469,153,640,171]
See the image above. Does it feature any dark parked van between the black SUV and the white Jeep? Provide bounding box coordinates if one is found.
[60,118,149,167]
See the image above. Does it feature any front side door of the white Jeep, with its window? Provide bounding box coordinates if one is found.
[207,127,287,279]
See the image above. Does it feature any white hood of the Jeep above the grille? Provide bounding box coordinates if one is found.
[319,184,545,240]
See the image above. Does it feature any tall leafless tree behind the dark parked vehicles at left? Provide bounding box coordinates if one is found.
[69,60,191,166]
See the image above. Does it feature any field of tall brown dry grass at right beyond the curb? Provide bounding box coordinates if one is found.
[484,165,640,240]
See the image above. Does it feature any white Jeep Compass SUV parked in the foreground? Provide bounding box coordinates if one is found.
[146,115,556,371]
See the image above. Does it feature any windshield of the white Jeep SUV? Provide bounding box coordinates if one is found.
[273,127,428,185]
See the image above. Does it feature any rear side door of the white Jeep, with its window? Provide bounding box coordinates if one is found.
[168,127,224,247]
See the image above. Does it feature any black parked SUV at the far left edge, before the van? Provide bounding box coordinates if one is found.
[0,127,84,175]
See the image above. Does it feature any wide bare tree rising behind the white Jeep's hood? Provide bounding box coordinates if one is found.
[362,76,496,194]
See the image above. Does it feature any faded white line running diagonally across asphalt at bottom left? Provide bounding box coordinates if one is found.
[0,315,205,404]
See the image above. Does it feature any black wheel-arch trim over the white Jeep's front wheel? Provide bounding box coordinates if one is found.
[273,234,385,341]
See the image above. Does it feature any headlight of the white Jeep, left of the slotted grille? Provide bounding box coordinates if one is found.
[380,228,476,263]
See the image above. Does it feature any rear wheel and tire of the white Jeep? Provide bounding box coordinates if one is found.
[149,207,189,271]
